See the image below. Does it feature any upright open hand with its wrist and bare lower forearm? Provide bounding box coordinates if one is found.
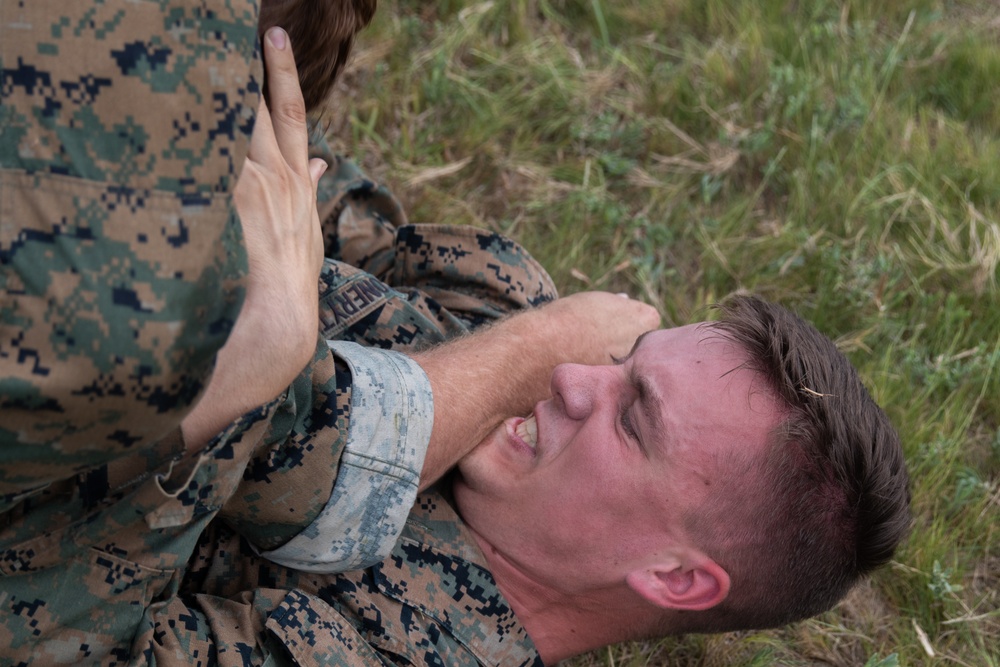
[181,28,326,447]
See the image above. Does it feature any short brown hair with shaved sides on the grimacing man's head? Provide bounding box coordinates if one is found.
[681,296,910,632]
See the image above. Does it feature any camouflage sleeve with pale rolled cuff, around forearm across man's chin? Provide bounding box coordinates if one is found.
[220,332,434,572]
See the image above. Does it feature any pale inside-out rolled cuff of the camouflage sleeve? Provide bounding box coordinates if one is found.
[262,341,434,573]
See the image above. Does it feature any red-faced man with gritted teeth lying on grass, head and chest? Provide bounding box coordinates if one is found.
[184,282,909,665]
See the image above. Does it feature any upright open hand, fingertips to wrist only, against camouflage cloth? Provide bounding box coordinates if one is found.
[233,28,327,380]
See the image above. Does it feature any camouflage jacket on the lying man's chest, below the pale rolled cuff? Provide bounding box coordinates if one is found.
[173,489,542,667]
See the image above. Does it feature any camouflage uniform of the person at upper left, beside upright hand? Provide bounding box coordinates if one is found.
[0,0,261,512]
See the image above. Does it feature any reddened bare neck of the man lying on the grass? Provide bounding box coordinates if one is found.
[472,530,648,665]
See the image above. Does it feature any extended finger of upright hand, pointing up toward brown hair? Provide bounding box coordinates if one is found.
[264,28,309,174]
